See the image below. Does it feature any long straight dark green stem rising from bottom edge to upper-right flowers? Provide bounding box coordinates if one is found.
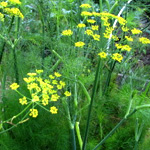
[82,58,101,150]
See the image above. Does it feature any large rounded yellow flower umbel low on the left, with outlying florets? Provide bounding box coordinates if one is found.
[10,70,71,118]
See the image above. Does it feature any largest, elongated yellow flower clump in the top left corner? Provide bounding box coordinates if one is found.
[4,8,24,19]
